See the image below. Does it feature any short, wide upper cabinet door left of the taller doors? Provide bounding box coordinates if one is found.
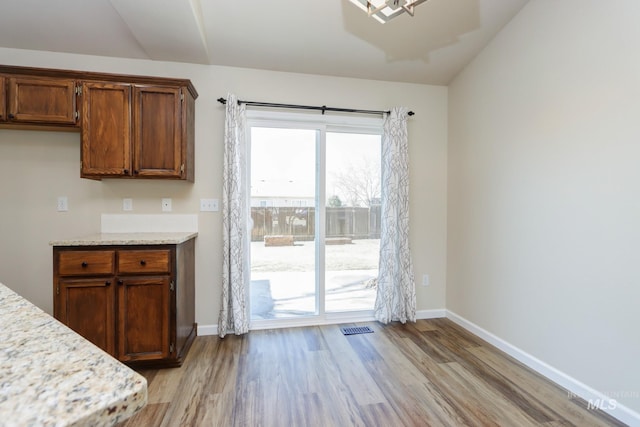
[7,77,77,125]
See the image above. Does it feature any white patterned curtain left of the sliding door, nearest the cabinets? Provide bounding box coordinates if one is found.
[218,94,249,338]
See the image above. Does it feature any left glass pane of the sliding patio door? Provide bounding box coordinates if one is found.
[250,127,318,319]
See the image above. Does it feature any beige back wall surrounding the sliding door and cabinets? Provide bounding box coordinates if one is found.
[0,49,447,325]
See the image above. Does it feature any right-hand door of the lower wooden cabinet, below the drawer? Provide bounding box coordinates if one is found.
[118,276,171,362]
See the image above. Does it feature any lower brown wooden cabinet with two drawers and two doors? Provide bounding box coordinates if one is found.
[53,239,196,367]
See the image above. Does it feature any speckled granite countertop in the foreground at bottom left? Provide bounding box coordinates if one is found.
[0,283,147,427]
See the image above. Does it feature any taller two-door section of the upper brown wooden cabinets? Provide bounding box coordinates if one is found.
[82,82,195,181]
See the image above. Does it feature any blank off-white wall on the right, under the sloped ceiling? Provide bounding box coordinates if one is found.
[447,0,640,411]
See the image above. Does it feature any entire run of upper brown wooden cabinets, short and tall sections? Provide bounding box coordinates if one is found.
[0,65,198,182]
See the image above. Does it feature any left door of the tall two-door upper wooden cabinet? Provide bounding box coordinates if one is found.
[81,82,131,178]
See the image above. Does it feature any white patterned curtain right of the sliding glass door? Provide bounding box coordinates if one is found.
[374,107,416,323]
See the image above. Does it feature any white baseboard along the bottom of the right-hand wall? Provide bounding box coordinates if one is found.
[446,310,640,426]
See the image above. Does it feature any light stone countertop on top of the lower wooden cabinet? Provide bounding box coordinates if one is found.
[49,231,198,246]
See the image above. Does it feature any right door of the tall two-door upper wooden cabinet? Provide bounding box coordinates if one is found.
[133,86,184,178]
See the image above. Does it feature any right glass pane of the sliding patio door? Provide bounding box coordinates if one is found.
[324,132,381,312]
